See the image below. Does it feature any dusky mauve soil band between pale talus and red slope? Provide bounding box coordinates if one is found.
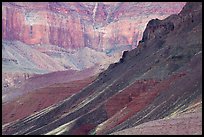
[2,66,100,103]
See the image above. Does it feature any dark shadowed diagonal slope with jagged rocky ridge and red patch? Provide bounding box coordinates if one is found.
[3,3,202,134]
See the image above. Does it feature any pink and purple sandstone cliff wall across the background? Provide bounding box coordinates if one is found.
[2,2,185,50]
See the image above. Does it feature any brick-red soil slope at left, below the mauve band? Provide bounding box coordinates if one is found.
[2,77,95,124]
